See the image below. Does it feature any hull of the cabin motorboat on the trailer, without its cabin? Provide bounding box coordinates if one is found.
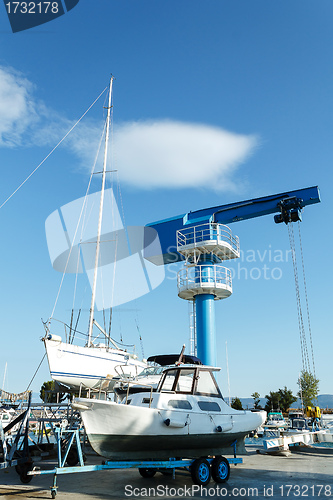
[73,393,266,460]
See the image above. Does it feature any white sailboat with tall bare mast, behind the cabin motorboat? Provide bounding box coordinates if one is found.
[42,76,147,389]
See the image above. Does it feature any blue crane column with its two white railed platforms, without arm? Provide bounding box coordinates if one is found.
[177,223,239,366]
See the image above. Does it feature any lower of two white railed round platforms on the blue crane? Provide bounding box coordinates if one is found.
[177,265,232,291]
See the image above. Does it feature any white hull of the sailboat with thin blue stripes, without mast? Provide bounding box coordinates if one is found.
[44,339,147,389]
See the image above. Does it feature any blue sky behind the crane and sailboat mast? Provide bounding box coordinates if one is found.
[0,0,333,397]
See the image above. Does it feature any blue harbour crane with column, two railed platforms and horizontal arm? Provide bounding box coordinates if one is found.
[144,186,320,365]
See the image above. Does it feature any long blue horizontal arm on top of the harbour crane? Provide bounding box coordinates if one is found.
[144,186,320,265]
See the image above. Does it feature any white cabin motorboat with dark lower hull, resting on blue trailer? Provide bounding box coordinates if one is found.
[73,364,266,460]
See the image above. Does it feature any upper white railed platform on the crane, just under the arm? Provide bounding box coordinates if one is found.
[177,222,239,256]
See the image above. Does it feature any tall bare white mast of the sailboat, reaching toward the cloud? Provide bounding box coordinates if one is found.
[88,75,114,346]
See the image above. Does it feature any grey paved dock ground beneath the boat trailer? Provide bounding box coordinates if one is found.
[0,445,333,500]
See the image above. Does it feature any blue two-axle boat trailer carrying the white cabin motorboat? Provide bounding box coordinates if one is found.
[27,428,243,498]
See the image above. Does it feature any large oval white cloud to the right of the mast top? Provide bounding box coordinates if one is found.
[115,120,258,189]
